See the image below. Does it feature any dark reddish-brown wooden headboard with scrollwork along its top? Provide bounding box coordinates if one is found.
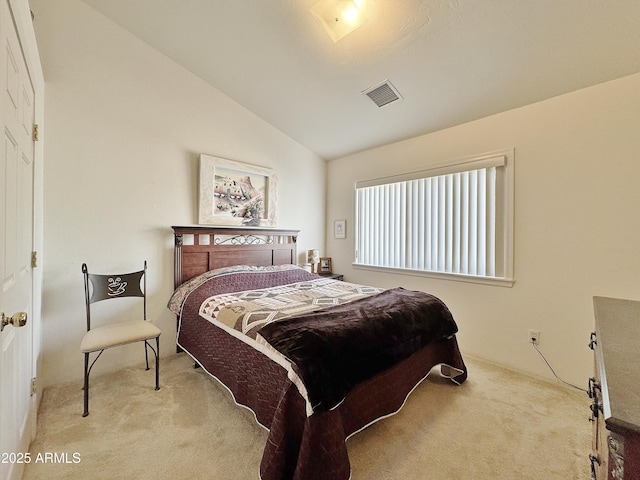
[171,225,300,287]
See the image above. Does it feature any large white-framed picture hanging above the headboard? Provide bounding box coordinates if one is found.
[198,155,278,227]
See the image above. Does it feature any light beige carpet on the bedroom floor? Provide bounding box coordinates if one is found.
[23,354,591,480]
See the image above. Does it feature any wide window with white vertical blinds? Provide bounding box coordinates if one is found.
[354,150,514,286]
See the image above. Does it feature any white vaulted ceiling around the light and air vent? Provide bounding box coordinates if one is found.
[84,0,640,160]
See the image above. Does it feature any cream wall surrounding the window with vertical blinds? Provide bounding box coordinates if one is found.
[326,74,640,386]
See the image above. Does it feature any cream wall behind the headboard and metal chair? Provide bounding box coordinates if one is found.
[31,0,326,388]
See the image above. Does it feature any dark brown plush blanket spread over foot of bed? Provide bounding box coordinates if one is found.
[259,288,458,411]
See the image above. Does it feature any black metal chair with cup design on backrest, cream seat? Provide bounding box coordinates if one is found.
[80,261,161,417]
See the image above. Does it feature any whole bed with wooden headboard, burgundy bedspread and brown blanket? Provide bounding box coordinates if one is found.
[169,226,467,480]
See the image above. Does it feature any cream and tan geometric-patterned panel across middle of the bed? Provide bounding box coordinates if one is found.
[199,278,383,340]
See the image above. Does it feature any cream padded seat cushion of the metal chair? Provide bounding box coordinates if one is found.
[80,320,161,353]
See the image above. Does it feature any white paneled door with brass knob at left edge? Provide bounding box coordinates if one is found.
[0,0,34,480]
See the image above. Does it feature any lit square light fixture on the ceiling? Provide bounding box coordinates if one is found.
[309,0,367,43]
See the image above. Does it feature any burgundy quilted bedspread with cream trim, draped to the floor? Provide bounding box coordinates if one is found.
[168,265,467,480]
